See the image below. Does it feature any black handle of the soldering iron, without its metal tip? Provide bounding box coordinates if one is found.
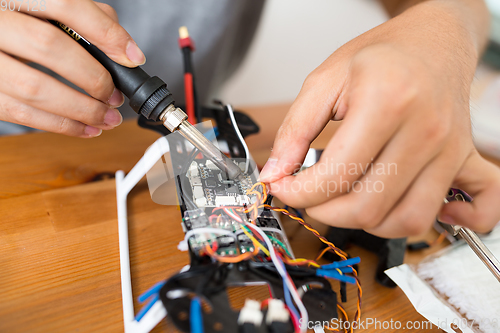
[49,20,174,121]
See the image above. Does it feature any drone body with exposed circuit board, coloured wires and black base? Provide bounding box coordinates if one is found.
[155,111,344,333]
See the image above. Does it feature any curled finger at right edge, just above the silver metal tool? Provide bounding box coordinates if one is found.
[438,151,500,233]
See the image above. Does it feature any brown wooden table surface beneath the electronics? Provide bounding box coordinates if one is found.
[0,105,466,332]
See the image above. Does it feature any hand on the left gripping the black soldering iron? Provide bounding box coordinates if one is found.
[0,0,145,138]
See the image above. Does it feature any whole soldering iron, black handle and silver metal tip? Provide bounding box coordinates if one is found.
[49,20,246,182]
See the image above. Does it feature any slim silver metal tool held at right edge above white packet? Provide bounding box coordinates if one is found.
[438,188,500,282]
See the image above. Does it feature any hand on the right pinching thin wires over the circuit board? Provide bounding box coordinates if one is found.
[261,4,500,237]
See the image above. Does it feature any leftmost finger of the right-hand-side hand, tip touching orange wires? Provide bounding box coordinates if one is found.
[259,72,340,183]
